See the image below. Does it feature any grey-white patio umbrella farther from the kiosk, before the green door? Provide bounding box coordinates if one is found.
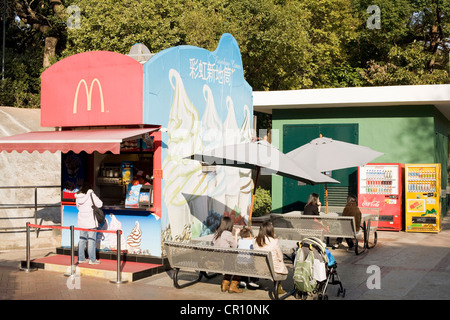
[286,135,384,213]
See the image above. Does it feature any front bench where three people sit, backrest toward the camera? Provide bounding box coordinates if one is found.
[164,241,293,300]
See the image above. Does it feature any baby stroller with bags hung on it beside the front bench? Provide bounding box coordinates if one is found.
[294,237,345,300]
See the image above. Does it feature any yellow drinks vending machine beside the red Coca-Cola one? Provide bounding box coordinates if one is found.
[405,163,441,232]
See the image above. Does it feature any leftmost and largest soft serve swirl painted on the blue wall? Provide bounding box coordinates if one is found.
[163,69,207,237]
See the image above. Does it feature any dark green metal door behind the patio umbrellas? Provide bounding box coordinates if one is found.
[282,123,358,212]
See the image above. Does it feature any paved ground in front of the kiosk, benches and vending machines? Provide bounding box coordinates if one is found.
[0,215,450,314]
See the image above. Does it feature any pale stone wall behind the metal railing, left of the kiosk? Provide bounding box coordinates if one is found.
[0,107,61,250]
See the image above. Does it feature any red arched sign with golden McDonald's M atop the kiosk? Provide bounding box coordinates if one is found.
[41,51,143,127]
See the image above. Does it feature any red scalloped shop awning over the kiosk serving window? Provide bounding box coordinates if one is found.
[0,128,158,154]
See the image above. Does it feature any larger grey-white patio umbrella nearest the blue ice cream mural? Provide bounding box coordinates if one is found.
[189,141,339,225]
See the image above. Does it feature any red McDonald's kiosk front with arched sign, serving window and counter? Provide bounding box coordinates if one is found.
[41,51,162,257]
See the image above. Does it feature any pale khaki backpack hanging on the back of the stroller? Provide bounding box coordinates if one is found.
[294,248,317,292]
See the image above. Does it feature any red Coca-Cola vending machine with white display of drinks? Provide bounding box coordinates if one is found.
[358,163,403,231]
